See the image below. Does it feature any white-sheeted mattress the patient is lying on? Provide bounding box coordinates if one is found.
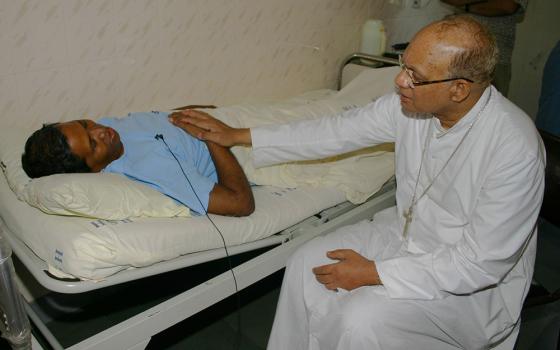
[0,70,402,280]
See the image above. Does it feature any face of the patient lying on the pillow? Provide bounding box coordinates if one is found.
[58,119,124,172]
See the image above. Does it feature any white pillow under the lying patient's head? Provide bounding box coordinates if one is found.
[0,128,190,220]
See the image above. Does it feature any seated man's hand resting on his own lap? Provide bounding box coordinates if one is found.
[313,249,381,290]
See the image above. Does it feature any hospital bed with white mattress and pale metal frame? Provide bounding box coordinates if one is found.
[0,54,398,349]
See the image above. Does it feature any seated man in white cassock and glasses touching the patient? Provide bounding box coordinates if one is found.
[172,16,545,350]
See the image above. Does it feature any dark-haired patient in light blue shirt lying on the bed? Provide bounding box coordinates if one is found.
[21,112,254,216]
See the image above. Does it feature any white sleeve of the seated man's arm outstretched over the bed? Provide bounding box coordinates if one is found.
[251,93,400,167]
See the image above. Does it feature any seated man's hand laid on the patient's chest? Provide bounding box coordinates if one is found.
[169,109,251,147]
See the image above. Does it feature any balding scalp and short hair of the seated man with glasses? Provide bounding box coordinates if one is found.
[413,15,498,86]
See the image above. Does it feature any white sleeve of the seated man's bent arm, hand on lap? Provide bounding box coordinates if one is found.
[376,135,544,299]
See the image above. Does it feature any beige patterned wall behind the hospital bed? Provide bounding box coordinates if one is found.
[0,0,379,127]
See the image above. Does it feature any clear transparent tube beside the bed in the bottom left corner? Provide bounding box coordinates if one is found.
[0,229,31,350]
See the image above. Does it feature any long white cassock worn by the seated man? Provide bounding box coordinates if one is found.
[251,87,545,350]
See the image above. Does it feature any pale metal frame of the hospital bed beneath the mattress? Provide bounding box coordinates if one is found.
[0,54,398,350]
